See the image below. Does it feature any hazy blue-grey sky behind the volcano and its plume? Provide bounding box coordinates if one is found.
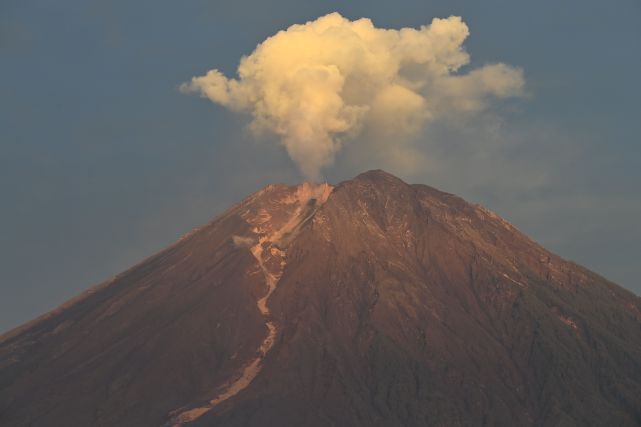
[0,0,641,331]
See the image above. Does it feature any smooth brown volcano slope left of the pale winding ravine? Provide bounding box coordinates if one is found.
[0,186,316,426]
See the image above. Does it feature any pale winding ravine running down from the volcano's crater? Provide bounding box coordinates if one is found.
[166,183,333,427]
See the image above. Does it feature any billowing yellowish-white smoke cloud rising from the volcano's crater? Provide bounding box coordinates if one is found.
[181,13,524,179]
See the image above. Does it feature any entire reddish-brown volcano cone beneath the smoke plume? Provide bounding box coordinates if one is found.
[0,171,641,426]
